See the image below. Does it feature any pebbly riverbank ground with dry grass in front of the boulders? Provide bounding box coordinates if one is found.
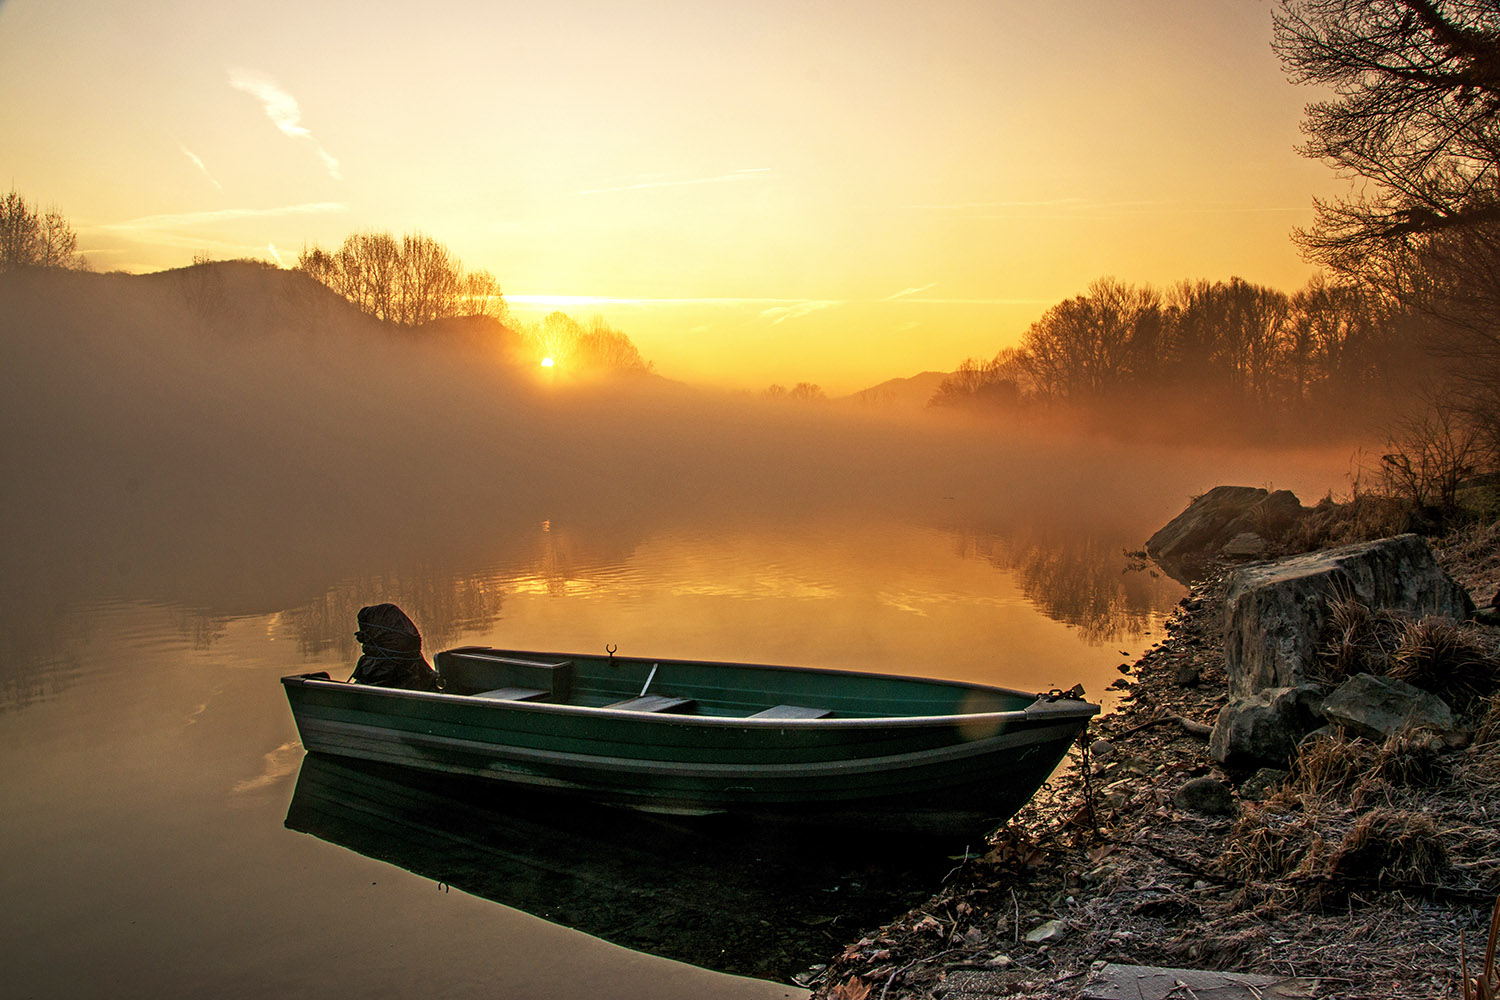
[815,515,1500,1000]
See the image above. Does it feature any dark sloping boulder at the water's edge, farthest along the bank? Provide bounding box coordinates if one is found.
[1146,486,1304,582]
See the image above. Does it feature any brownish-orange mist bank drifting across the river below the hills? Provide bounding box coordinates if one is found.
[0,264,1352,626]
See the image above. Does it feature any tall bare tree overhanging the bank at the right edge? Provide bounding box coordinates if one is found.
[1275,0,1500,442]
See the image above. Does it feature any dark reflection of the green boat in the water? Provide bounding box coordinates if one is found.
[287,753,960,982]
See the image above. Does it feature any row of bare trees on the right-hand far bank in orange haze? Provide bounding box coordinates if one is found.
[930,277,1413,429]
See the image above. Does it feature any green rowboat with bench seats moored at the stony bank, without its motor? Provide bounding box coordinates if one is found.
[282,646,1100,834]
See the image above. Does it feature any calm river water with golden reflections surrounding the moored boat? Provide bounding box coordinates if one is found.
[0,479,1338,1000]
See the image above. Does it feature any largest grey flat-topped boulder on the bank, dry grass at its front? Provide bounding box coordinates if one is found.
[1224,535,1475,697]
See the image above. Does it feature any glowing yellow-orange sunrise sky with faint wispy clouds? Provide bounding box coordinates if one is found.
[0,0,1343,394]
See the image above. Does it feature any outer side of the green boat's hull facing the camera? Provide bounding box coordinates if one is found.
[284,656,1097,834]
